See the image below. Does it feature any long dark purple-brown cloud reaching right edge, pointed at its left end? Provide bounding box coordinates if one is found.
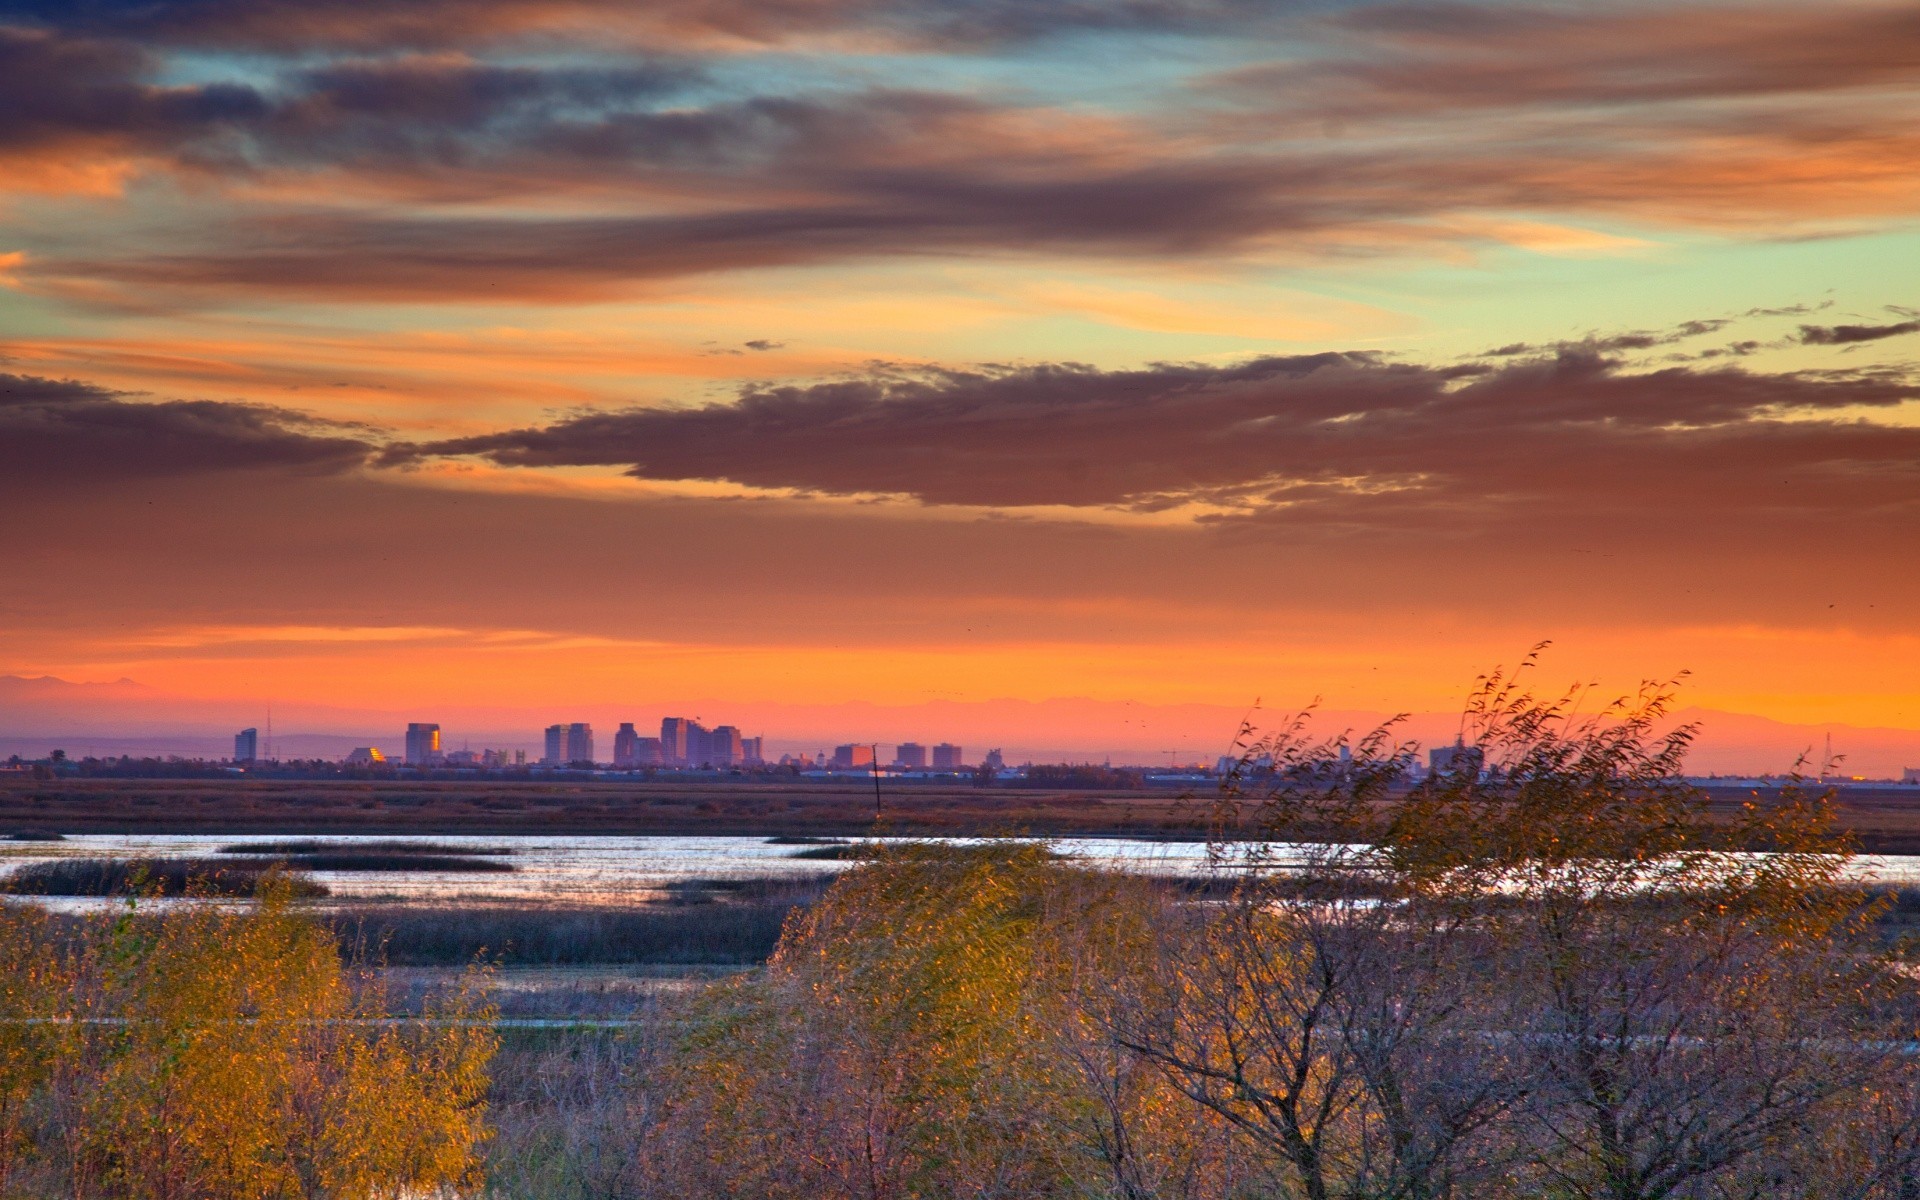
[386,351,1920,528]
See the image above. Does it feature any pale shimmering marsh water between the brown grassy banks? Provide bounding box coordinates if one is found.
[0,833,1920,906]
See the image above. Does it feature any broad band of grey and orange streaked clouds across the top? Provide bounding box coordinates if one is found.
[0,0,1920,303]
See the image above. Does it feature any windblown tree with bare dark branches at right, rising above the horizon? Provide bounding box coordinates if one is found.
[1121,660,1910,1200]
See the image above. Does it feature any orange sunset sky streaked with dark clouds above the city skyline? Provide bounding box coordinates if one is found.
[0,0,1920,770]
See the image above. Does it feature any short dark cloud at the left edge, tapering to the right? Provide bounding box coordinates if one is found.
[0,374,372,488]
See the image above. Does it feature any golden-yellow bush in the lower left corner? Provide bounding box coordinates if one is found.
[0,879,493,1200]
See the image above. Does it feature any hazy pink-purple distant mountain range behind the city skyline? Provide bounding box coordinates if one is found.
[0,676,1920,778]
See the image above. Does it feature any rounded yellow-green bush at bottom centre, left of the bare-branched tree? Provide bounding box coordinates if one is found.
[660,843,1217,1200]
